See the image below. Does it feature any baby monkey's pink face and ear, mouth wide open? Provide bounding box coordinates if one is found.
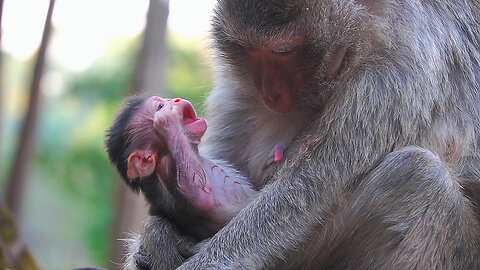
[127,96,207,179]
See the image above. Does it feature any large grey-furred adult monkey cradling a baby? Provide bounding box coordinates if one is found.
[125,0,480,269]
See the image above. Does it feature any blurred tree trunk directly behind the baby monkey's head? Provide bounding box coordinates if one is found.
[110,0,168,269]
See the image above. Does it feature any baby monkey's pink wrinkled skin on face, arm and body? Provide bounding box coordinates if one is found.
[125,96,257,239]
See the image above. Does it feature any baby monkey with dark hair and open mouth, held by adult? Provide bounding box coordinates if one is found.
[107,96,258,239]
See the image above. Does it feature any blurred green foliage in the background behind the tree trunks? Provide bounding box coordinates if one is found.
[0,33,211,269]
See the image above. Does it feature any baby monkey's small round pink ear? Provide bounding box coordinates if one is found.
[127,149,157,179]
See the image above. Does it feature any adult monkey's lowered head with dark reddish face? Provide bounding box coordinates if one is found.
[213,0,360,114]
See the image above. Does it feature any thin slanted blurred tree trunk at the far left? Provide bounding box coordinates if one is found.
[7,0,55,218]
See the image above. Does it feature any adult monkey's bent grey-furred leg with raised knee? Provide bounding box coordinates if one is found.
[287,148,480,269]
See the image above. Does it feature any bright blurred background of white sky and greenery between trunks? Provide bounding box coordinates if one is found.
[0,0,215,269]
